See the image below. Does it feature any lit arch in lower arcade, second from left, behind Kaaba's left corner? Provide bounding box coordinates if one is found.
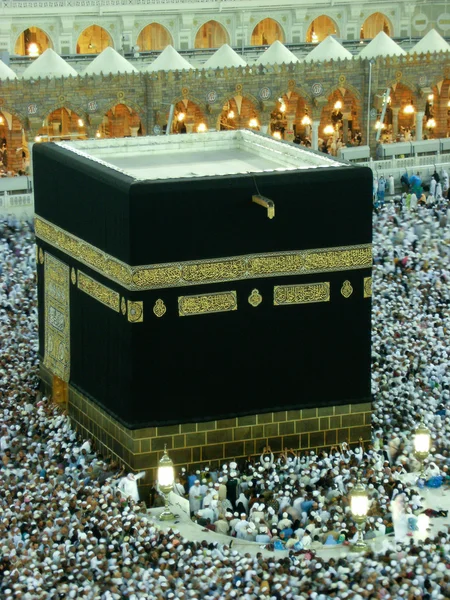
[35,106,87,142]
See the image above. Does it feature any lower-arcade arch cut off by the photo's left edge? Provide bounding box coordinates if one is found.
[0,106,30,173]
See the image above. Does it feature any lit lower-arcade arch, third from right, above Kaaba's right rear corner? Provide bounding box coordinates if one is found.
[319,85,362,151]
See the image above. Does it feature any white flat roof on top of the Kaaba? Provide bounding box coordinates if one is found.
[56,130,348,181]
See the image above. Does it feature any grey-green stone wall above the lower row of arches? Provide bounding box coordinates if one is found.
[0,53,450,156]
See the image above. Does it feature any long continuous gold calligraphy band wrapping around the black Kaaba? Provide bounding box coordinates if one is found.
[35,217,372,291]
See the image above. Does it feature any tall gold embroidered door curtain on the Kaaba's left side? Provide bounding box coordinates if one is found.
[44,252,70,381]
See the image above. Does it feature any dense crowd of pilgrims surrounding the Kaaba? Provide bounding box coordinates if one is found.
[0,180,450,600]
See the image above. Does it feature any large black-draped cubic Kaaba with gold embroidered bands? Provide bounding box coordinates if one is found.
[33,130,372,478]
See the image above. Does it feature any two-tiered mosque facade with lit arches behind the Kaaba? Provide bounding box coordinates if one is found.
[0,0,450,172]
